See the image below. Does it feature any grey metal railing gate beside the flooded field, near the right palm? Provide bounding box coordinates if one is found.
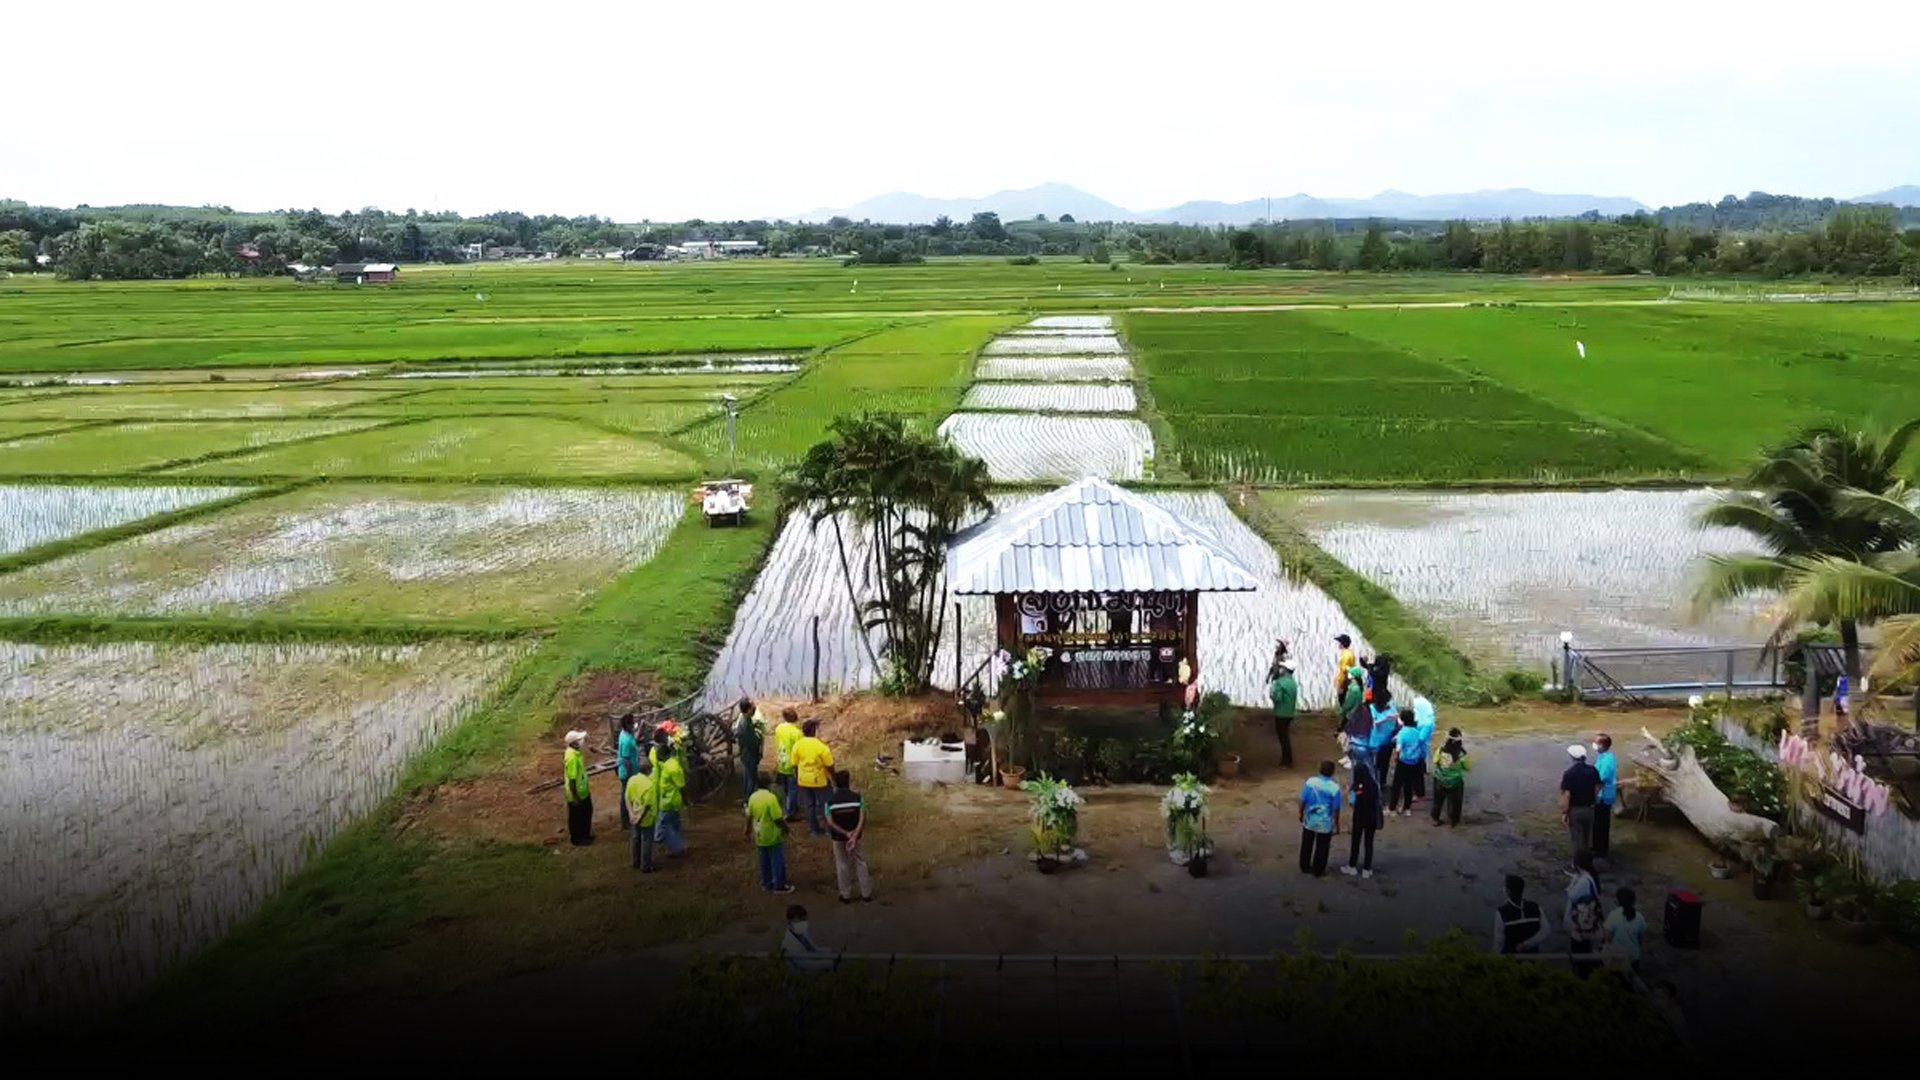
[1557,642,1786,703]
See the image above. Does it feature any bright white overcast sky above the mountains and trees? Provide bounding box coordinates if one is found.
[0,0,1920,221]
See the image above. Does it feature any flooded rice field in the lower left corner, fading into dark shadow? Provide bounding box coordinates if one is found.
[0,642,524,1019]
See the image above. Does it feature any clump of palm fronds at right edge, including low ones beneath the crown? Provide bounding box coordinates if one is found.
[1695,419,1920,726]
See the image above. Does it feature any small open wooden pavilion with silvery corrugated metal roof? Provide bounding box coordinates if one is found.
[947,477,1260,705]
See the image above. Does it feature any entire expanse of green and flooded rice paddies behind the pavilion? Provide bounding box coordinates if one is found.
[0,259,1920,1028]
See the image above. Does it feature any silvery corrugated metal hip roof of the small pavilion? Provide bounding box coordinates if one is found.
[947,477,1260,596]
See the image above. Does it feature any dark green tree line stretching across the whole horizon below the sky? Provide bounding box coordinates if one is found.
[0,194,1920,281]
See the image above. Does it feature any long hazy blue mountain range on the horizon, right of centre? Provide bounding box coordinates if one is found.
[801,184,1647,225]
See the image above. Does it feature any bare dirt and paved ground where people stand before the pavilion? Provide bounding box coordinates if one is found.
[366,711,1912,1038]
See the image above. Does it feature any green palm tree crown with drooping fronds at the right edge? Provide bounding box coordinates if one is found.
[1693,419,1920,703]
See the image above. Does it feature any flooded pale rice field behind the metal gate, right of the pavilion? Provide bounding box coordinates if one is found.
[1288,490,1770,669]
